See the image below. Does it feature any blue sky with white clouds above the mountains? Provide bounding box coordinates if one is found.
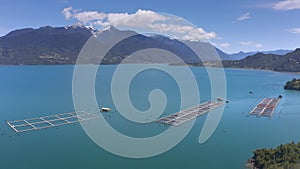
[0,0,300,53]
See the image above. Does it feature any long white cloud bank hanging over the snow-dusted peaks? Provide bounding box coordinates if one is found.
[61,7,217,41]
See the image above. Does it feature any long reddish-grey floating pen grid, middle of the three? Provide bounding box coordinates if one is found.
[156,101,224,126]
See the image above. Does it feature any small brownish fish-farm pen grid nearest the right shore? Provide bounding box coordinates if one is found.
[249,98,281,117]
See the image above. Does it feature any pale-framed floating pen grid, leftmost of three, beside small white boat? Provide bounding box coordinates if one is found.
[6,112,99,133]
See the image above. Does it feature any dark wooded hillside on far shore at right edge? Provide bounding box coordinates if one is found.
[223,48,300,72]
